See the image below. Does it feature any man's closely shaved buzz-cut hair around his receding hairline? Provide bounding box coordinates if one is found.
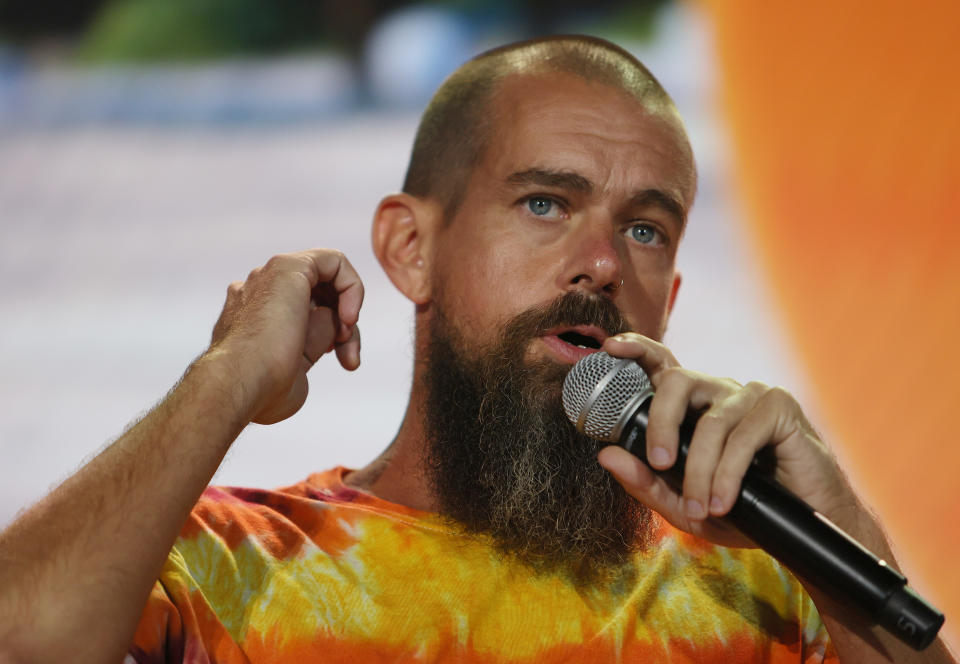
[403,36,694,219]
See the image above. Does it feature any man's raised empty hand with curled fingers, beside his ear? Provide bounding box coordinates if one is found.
[205,249,363,424]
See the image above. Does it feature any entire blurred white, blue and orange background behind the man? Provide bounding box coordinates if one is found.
[0,0,960,648]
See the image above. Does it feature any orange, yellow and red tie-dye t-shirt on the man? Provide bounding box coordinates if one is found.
[127,468,836,664]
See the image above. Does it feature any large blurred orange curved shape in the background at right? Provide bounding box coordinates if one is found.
[703,0,960,641]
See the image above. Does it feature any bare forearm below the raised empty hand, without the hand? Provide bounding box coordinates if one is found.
[0,356,246,662]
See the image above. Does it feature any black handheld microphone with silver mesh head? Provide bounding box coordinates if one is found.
[563,352,944,650]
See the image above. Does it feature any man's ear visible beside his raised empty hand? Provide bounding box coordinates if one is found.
[372,194,439,304]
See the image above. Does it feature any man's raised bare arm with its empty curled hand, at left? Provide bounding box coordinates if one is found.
[0,249,363,662]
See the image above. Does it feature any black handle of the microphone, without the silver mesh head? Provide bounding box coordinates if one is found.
[621,399,944,650]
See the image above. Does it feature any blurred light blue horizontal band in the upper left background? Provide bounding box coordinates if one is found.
[0,56,358,127]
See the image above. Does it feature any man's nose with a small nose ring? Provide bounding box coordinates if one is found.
[562,219,623,296]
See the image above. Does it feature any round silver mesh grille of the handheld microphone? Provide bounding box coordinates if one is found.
[563,351,650,443]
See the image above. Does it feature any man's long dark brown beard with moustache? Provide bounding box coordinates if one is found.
[424,293,651,582]
